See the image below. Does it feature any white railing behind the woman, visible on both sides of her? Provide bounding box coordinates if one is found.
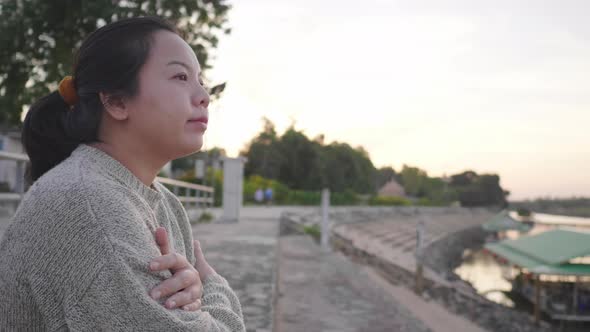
[0,151,214,208]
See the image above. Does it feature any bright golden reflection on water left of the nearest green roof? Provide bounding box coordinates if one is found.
[455,250,514,308]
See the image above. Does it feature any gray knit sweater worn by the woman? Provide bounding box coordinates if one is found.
[0,144,245,332]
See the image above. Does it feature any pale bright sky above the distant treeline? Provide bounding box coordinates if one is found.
[205,0,590,200]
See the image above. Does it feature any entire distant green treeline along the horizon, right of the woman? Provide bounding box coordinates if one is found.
[241,118,508,206]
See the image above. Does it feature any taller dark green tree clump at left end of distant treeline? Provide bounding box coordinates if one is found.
[241,119,377,195]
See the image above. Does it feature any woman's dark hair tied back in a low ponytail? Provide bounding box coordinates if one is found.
[22,17,178,185]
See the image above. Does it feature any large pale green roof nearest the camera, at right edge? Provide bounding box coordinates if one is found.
[485,229,590,275]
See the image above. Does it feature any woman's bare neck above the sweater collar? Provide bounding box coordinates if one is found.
[88,142,167,187]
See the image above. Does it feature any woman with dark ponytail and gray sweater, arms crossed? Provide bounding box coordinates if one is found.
[0,17,245,331]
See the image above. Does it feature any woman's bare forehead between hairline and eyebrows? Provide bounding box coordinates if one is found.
[147,30,201,73]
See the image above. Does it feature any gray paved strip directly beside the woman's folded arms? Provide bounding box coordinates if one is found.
[193,208,280,332]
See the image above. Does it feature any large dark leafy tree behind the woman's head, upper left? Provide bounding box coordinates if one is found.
[0,0,230,126]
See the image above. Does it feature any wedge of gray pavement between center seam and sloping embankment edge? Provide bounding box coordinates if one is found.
[276,235,428,332]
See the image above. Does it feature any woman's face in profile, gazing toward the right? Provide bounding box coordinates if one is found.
[125,31,209,160]
